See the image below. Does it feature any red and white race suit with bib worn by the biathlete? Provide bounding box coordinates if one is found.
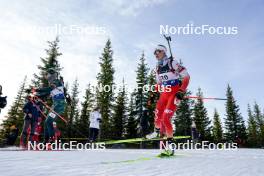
[155,57,190,137]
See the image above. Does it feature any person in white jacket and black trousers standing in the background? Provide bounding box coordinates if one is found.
[89,107,102,142]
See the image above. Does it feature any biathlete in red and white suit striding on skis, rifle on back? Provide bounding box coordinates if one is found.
[147,38,190,155]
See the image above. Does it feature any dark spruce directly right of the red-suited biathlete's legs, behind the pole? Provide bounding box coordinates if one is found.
[174,92,194,136]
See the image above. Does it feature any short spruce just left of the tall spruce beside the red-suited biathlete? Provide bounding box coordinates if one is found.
[125,93,139,139]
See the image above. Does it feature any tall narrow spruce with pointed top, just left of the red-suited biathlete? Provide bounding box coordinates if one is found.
[135,53,149,128]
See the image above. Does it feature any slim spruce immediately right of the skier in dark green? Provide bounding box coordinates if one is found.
[67,79,79,137]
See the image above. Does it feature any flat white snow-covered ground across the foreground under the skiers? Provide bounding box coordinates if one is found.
[0,149,264,176]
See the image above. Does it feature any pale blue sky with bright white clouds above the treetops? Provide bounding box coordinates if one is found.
[0,0,264,124]
